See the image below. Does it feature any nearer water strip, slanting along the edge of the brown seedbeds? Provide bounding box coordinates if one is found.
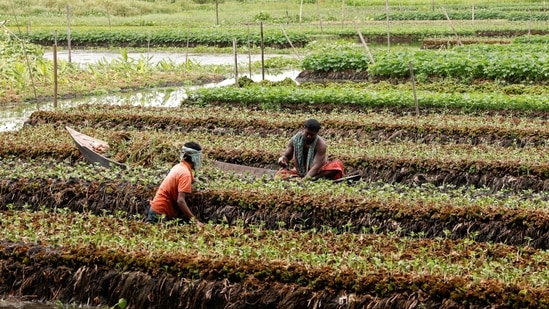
[0,70,300,132]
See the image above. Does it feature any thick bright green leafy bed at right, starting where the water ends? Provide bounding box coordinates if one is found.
[303,43,549,83]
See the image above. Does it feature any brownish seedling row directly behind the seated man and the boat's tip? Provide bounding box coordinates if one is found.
[6,124,547,177]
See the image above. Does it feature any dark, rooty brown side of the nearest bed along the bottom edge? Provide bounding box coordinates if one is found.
[0,242,547,309]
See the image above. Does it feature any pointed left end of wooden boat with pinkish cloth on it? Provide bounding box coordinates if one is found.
[65,127,127,169]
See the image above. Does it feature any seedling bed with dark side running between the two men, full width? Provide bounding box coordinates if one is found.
[0,159,549,248]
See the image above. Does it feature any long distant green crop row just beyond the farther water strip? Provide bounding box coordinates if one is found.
[13,19,548,48]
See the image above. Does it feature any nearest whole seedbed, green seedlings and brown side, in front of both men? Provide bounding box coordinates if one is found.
[0,210,549,308]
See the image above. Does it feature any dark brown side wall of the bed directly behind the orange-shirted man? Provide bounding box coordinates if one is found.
[0,179,549,249]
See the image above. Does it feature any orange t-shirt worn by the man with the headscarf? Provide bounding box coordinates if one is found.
[150,161,193,219]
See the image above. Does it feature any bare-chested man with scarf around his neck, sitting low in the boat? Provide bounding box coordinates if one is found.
[276,119,344,180]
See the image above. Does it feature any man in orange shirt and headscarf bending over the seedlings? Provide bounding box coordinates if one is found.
[146,142,204,226]
